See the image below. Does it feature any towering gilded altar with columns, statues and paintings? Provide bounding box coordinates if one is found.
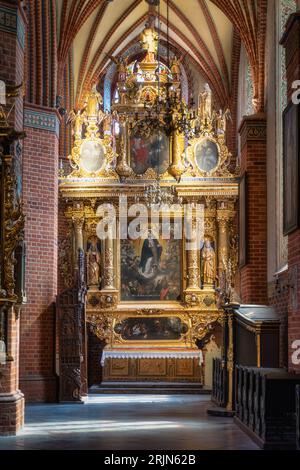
[60,27,238,385]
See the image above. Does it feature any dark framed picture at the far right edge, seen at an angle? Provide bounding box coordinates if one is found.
[283,103,300,235]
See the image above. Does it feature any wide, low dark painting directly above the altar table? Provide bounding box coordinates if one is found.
[115,317,188,341]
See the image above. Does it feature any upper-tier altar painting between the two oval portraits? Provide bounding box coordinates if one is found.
[130,133,170,175]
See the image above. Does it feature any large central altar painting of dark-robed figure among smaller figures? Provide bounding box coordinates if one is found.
[121,228,181,301]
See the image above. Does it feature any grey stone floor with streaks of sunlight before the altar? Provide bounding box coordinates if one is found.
[0,395,257,450]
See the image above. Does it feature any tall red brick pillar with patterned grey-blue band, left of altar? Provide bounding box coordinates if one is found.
[20,104,59,402]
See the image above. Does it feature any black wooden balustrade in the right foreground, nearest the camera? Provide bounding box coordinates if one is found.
[235,366,300,449]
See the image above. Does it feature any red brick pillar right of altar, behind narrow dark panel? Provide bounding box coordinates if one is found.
[239,114,268,304]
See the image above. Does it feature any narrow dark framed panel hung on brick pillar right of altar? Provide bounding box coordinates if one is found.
[239,173,248,268]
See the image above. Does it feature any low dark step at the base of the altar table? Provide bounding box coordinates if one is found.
[89,382,211,395]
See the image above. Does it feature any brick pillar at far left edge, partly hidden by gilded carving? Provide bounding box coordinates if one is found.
[0,1,26,435]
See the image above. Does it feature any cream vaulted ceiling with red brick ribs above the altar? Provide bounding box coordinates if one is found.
[56,0,268,112]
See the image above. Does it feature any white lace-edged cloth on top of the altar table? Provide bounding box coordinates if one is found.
[101,349,204,367]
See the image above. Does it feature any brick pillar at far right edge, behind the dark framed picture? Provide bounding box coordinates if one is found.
[281,13,300,372]
